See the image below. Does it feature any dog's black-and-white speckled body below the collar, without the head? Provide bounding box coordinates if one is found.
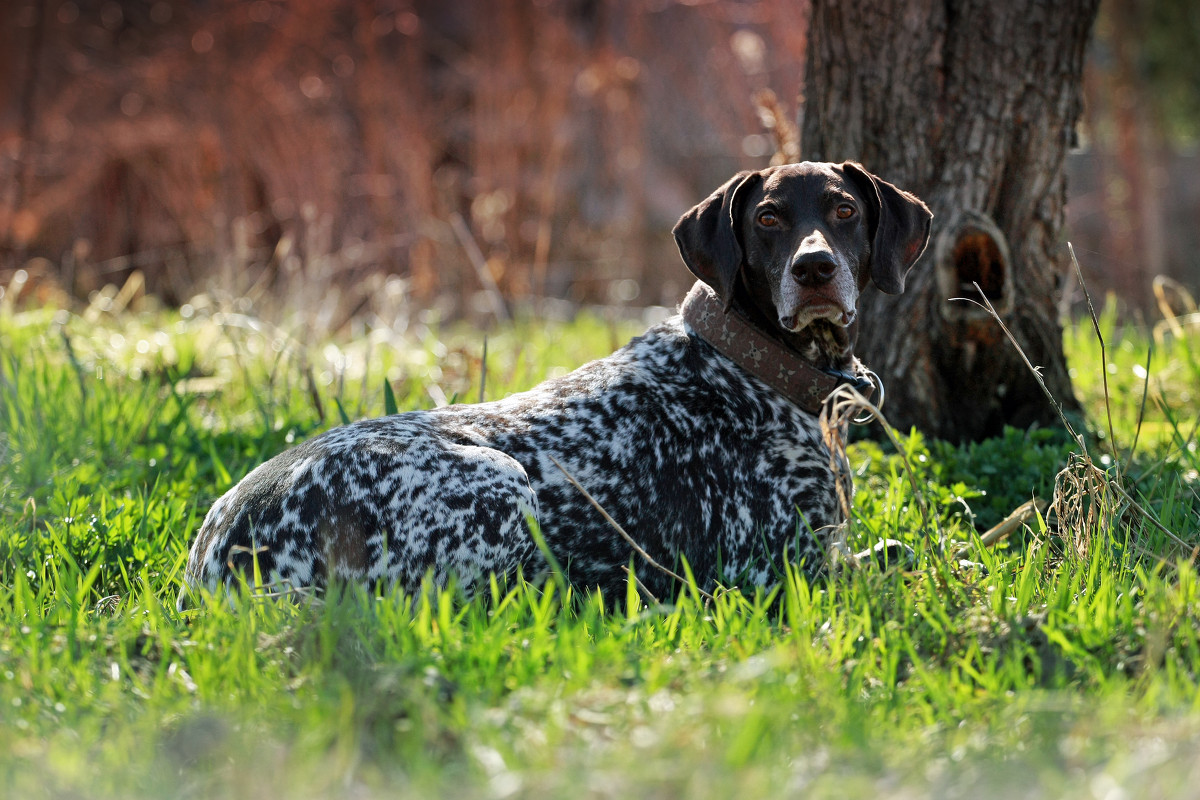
[186,317,840,606]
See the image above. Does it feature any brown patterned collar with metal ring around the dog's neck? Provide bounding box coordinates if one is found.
[679,281,875,414]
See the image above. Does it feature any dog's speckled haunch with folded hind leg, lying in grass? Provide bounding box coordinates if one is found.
[180,435,545,607]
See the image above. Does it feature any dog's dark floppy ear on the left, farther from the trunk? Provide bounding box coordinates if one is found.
[671,172,761,311]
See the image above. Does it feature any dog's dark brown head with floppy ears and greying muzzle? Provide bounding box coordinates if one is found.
[674,161,932,361]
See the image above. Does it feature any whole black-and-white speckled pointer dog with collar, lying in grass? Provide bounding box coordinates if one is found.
[179,162,932,608]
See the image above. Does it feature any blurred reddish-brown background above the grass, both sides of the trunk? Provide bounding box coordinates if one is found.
[0,0,1200,330]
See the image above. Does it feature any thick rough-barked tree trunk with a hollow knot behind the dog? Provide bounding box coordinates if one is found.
[800,0,1098,440]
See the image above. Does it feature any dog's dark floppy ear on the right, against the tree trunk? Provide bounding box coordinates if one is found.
[841,161,934,294]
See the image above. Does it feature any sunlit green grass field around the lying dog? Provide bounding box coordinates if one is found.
[0,291,1200,799]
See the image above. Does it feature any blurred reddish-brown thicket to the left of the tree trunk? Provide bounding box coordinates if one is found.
[0,0,805,319]
